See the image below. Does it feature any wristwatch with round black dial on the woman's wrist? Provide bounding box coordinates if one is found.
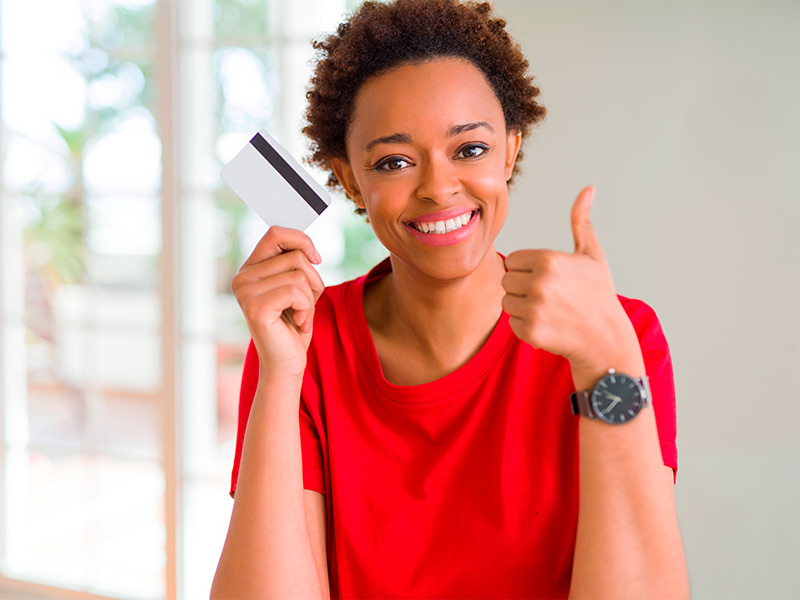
[569,369,650,425]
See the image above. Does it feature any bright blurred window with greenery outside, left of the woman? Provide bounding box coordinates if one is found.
[0,0,385,599]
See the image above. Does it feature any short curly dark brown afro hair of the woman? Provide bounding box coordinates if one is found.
[303,0,546,214]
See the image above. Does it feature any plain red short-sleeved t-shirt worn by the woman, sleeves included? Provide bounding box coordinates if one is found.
[231,260,677,598]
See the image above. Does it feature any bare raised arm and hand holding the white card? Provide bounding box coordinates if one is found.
[211,227,330,598]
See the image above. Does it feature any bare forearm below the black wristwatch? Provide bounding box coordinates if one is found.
[570,407,689,599]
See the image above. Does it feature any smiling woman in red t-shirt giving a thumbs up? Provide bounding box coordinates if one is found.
[212,0,688,598]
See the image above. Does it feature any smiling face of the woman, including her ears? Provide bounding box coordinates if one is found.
[333,58,520,279]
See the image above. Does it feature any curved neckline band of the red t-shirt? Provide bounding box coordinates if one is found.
[345,258,515,404]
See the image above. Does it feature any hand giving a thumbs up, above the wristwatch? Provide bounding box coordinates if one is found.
[503,186,644,389]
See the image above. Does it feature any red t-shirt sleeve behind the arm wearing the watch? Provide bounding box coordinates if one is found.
[623,299,678,484]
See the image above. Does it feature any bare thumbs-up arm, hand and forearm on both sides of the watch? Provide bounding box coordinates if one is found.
[503,187,689,598]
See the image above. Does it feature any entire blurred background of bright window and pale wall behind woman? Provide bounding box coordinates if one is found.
[0,0,800,600]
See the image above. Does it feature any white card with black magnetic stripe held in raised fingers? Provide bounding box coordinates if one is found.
[222,129,331,231]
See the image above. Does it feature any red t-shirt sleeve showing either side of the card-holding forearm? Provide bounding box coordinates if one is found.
[230,340,325,498]
